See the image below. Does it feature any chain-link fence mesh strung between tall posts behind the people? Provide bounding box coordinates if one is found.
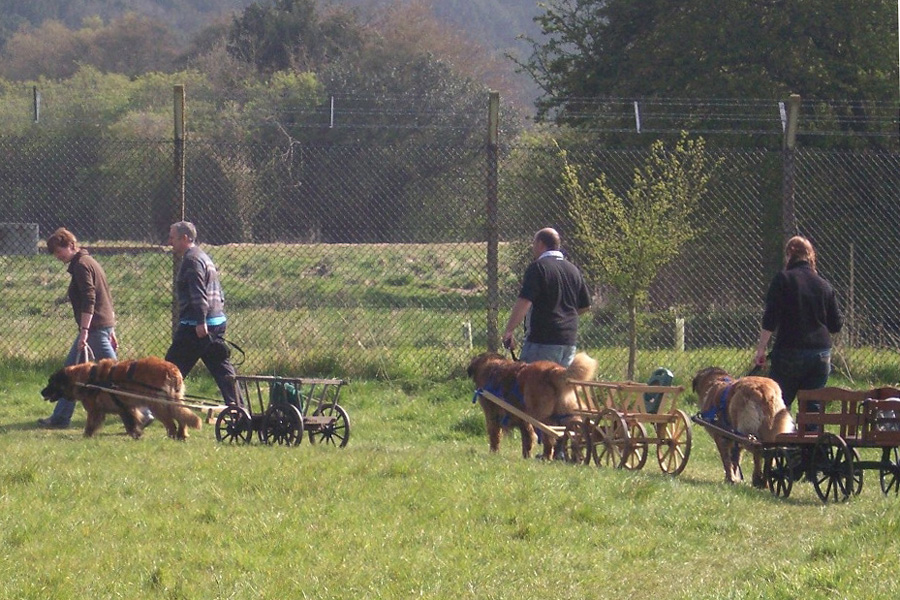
[0,136,900,382]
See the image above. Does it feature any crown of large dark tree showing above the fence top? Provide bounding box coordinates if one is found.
[519,0,897,143]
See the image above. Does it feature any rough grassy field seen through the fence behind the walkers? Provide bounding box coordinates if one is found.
[0,243,900,387]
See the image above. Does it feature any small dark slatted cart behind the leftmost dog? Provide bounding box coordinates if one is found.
[216,375,350,448]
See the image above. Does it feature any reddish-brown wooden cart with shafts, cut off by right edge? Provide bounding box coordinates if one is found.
[693,387,900,502]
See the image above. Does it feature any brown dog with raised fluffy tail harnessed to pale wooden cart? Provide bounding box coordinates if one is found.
[467,352,597,460]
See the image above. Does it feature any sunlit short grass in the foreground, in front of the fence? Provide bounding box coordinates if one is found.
[0,363,900,600]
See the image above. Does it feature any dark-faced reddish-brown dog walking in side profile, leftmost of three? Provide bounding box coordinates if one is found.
[41,357,201,440]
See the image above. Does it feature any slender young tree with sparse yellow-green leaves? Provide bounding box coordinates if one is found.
[560,134,716,379]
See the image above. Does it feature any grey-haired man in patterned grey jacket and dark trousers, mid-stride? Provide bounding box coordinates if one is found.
[166,221,238,404]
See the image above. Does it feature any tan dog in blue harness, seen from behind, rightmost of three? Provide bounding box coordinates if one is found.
[693,367,795,488]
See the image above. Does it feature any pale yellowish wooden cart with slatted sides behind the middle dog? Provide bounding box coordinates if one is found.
[564,380,692,475]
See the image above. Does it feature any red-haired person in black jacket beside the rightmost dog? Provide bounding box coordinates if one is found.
[755,236,844,409]
